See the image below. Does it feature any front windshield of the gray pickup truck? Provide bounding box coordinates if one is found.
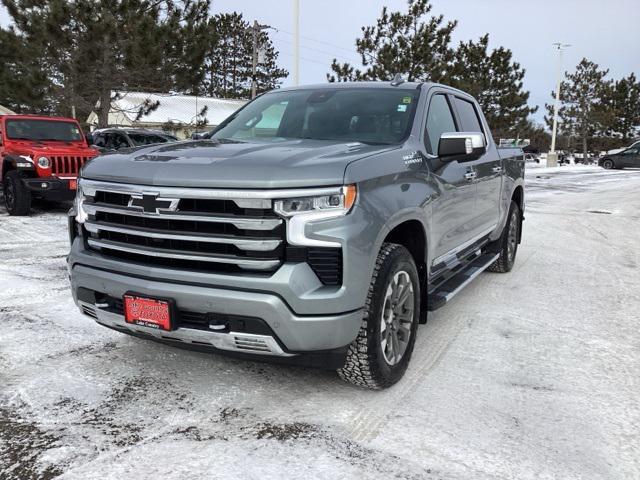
[212,88,418,144]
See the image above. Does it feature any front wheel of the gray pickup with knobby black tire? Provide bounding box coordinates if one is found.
[338,243,420,390]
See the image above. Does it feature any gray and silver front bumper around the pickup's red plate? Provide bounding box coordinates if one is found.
[71,264,362,357]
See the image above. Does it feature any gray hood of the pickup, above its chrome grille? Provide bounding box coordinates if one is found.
[82,140,399,189]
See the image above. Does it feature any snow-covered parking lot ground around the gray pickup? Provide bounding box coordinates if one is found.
[0,166,640,480]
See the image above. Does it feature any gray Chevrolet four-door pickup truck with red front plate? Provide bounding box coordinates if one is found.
[68,81,524,388]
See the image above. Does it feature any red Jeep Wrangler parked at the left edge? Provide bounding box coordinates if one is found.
[0,115,98,215]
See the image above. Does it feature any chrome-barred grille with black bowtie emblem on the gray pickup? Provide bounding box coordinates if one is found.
[82,180,286,274]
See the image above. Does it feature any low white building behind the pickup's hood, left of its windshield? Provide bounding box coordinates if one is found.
[87,92,247,138]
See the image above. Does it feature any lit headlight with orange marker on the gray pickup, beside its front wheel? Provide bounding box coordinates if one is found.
[274,185,356,218]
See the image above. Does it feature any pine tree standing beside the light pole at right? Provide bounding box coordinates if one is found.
[545,58,615,158]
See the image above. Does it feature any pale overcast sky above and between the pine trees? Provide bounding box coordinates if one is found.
[0,0,640,121]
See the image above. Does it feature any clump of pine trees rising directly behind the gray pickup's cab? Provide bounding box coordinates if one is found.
[327,0,537,136]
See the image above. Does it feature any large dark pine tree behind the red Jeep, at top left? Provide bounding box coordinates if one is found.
[2,0,209,126]
